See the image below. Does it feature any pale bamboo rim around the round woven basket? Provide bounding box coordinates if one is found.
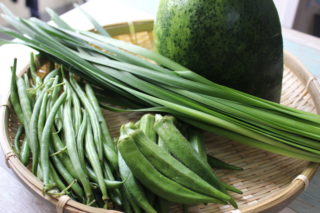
[0,20,320,213]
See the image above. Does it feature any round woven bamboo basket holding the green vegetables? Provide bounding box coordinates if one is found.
[0,20,320,213]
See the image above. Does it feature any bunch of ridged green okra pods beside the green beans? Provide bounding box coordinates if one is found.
[117,114,242,212]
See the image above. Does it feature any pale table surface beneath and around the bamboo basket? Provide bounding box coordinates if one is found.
[0,0,320,213]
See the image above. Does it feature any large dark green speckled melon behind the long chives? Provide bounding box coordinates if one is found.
[154,0,283,102]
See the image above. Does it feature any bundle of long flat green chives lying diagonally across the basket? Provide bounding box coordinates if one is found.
[1,13,320,162]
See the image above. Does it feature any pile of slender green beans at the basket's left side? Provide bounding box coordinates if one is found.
[10,54,122,209]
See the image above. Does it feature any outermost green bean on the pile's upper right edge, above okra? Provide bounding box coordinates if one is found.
[85,84,118,151]
